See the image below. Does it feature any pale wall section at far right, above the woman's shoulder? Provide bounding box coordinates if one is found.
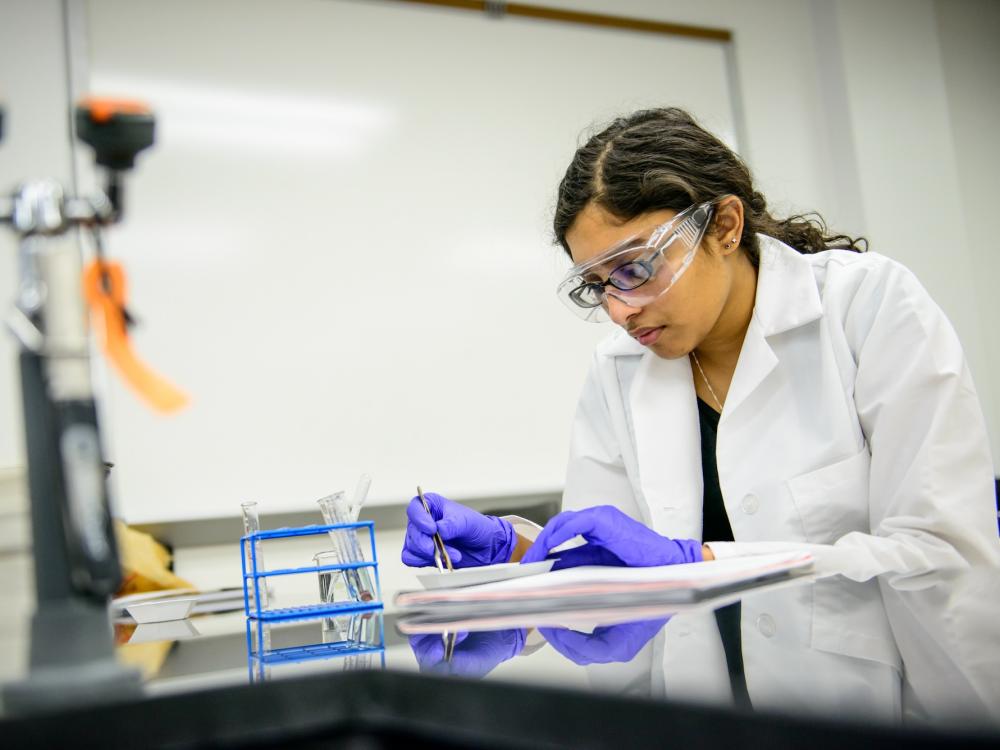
[838,0,1000,470]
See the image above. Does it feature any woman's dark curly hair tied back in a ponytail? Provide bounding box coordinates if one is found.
[552,107,868,265]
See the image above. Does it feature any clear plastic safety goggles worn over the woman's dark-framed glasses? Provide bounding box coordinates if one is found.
[556,199,718,323]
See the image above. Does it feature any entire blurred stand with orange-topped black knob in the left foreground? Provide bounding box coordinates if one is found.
[0,99,182,713]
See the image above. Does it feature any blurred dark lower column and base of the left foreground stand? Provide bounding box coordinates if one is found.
[3,352,141,715]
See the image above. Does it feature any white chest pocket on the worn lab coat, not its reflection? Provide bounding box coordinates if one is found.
[788,446,871,544]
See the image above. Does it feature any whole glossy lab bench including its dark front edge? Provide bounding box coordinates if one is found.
[0,571,1000,750]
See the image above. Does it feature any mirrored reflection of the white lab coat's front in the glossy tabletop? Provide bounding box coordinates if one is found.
[587,578,902,723]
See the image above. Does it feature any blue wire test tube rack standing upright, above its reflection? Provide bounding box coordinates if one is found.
[240,521,383,622]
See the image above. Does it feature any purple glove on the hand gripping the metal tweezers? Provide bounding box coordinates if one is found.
[401,492,517,568]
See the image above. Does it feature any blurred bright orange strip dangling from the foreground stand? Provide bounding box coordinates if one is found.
[83,261,190,413]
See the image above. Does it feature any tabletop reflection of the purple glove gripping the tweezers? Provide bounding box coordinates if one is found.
[410,628,527,677]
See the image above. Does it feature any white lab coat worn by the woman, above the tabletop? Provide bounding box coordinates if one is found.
[563,235,1000,580]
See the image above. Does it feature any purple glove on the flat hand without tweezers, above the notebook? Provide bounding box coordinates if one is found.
[521,505,702,570]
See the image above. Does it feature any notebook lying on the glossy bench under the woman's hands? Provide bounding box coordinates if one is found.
[395,552,813,614]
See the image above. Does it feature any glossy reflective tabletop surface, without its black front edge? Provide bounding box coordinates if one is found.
[88,570,1000,733]
